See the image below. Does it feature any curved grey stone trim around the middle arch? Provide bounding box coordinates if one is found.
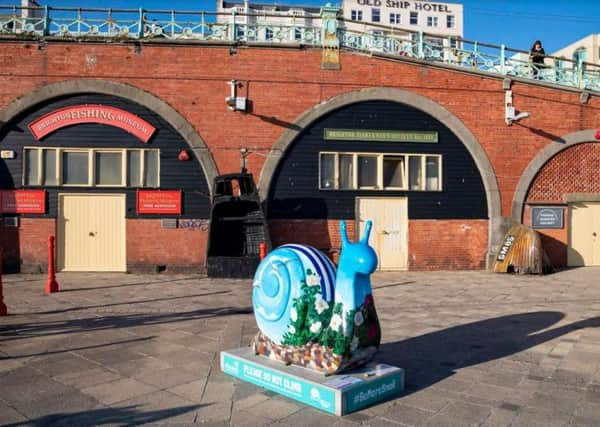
[258,87,503,263]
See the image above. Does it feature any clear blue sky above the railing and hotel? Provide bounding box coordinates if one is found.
[10,0,600,53]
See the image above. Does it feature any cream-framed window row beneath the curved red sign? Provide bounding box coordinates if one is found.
[23,147,160,188]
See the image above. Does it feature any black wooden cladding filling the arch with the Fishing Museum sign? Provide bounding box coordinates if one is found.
[0,93,210,218]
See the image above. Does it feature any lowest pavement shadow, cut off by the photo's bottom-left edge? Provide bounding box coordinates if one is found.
[6,405,207,427]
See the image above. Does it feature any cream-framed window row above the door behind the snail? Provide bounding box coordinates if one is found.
[319,152,442,191]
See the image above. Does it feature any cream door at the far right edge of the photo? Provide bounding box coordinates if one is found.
[567,202,600,267]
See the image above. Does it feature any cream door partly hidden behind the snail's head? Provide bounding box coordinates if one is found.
[357,197,408,270]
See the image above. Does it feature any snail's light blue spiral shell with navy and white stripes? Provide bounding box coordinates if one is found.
[252,244,336,344]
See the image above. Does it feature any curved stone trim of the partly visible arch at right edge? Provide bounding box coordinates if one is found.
[512,129,597,222]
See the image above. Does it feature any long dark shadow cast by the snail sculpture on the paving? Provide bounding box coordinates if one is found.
[377,311,600,394]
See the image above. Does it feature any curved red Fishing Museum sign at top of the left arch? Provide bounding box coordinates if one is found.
[28,104,156,142]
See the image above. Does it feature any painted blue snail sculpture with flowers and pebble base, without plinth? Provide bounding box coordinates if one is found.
[252,221,381,375]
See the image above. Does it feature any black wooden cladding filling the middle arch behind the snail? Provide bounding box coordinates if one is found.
[268,101,488,219]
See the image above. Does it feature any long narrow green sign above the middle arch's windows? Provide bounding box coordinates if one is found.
[323,128,438,144]
